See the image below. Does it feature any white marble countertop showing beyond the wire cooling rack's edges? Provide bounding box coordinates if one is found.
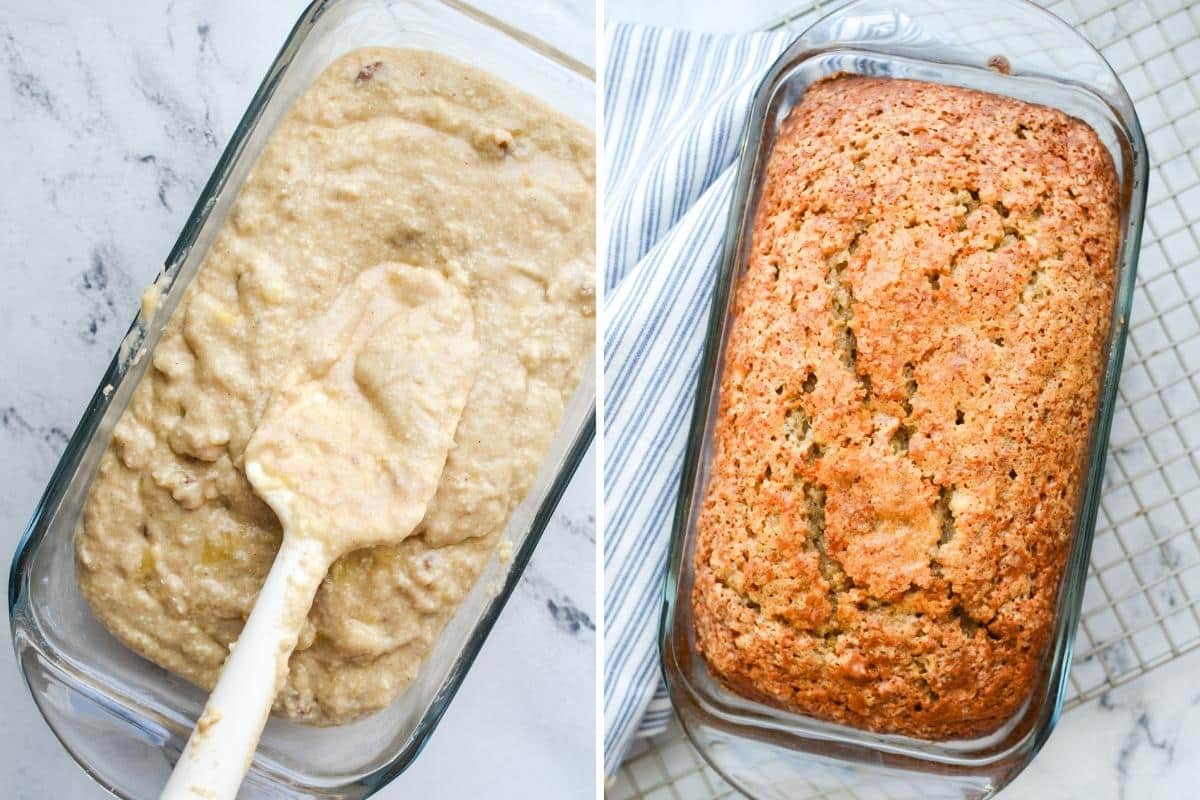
[605,0,1200,800]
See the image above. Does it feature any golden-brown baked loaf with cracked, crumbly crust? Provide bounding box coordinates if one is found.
[691,77,1118,740]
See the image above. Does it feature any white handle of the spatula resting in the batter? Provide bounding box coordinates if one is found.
[162,535,330,800]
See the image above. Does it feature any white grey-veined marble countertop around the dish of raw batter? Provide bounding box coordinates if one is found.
[0,0,596,800]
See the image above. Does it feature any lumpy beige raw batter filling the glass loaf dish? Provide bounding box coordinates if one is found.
[76,48,595,724]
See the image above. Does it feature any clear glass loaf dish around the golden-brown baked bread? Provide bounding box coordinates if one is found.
[659,0,1147,800]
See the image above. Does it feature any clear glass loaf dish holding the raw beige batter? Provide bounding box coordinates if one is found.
[8,0,595,799]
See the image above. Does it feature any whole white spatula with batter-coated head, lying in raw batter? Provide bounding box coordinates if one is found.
[162,264,479,800]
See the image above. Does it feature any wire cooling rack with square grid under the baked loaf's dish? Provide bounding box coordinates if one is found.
[607,0,1200,800]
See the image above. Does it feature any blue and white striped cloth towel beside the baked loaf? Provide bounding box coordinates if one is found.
[604,25,794,775]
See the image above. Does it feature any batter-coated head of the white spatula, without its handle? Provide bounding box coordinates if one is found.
[245,264,479,555]
